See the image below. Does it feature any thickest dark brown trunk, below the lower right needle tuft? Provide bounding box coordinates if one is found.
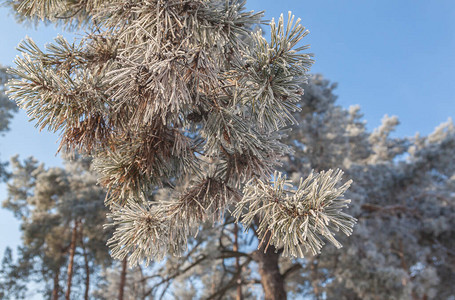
[253,246,287,300]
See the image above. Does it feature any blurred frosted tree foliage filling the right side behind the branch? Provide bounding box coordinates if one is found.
[285,77,455,299]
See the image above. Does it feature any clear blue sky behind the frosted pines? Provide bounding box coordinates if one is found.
[0,0,455,255]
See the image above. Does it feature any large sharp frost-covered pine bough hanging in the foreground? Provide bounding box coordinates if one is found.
[8,0,355,299]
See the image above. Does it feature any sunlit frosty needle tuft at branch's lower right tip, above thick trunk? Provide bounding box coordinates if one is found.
[233,170,356,257]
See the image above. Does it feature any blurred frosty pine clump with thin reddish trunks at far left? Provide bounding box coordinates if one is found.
[0,157,111,299]
